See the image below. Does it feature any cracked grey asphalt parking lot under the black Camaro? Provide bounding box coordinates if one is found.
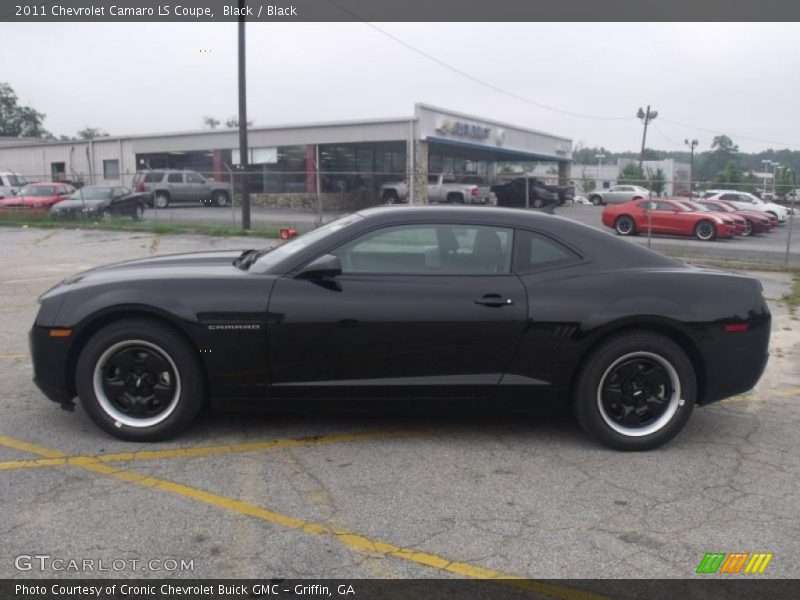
[0,226,800,584]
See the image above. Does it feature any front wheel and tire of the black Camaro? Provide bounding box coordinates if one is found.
[75,319,205,442]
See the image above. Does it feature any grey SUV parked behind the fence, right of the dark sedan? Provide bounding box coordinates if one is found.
[133,169,232,208]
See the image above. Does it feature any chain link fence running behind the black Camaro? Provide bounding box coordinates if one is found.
[0,168,800,267]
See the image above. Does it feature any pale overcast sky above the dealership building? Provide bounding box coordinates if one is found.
[0,23,800,152]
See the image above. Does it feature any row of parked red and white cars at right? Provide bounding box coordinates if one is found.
[602,196,779,241]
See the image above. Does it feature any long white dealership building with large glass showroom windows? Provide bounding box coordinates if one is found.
[0,104,572,203]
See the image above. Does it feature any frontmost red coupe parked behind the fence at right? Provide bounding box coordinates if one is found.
[603,199,736,242]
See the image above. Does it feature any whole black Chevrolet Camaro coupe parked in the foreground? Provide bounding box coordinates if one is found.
[30,207,770,450]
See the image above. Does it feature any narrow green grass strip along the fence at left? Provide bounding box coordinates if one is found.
[0,213,280,239]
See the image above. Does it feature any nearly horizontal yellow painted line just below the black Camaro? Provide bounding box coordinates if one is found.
[0,427,456,471]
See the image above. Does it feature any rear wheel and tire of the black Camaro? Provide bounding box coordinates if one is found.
[573,331,697,450]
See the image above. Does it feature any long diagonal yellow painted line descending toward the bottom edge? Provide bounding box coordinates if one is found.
[0,436,610,600]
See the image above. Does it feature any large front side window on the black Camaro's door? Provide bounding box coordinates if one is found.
[334,224,512,275]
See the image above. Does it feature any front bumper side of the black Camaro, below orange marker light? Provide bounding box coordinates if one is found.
[28,325,73,404]
